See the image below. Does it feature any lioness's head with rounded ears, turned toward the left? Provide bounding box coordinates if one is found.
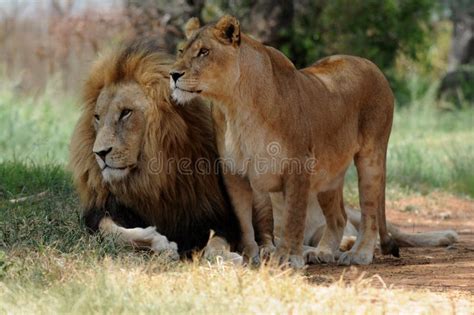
[170,16,241,103]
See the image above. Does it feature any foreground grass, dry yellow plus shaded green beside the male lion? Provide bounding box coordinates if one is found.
[0,162,472,314]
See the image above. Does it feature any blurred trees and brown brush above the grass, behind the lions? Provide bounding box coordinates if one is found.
[0,0,474,107]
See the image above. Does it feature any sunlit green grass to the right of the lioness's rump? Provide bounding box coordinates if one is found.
[346,102,474,203]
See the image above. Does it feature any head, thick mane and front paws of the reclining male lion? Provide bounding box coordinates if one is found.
[70,40,240,257]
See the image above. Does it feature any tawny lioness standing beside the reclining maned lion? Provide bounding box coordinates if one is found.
[170,16,399,267]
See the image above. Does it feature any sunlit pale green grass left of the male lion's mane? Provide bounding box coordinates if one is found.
[0,85,79,164]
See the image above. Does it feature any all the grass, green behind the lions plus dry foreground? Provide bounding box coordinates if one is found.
[0,82,474,314]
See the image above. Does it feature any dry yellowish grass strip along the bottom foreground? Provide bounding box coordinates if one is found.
[0,250,474,314]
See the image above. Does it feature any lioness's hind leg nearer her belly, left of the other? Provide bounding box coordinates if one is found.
[305,189,347,263]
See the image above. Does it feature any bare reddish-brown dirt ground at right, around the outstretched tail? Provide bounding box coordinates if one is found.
[308,193,474,297]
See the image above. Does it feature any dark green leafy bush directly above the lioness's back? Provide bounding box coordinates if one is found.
[281,0,435,70]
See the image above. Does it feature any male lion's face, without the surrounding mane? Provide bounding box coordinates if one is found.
[91,83,148,182]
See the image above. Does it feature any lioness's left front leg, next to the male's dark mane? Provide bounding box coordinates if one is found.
[224,172,260,265]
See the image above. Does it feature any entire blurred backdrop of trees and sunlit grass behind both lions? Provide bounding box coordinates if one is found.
[0,0,474,198]
